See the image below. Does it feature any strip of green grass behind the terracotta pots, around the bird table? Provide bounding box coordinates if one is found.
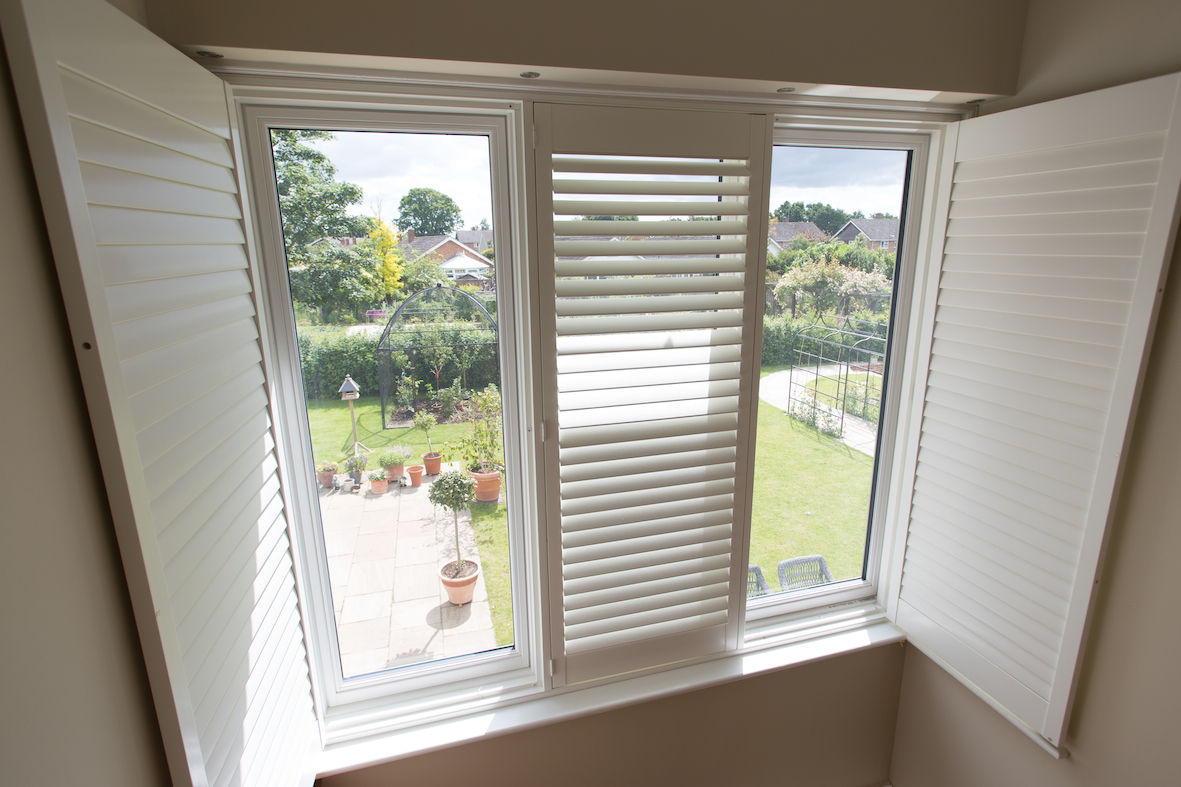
[307,396,471,466]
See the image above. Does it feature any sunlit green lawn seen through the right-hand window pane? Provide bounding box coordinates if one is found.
[750,402,874,579]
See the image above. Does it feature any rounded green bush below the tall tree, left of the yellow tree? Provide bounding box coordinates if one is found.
[291,243,383,321]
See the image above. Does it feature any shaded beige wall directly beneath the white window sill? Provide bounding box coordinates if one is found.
[319,645,902,787]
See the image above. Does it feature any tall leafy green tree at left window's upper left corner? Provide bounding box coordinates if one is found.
[270,129,370,266]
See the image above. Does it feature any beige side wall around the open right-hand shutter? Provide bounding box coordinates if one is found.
[890,0,1181,787]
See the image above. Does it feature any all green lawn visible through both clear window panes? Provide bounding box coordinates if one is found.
[308,382,874,633]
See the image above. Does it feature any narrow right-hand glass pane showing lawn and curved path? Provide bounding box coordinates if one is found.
[748,145,909,597]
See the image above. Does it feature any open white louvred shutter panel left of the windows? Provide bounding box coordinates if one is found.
[4,0,319,785]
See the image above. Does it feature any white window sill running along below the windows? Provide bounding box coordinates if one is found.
[317,603,905,776]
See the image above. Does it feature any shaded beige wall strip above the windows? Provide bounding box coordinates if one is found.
[138,0,1026,95]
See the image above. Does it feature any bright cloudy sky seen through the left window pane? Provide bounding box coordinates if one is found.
[312,131,492,229]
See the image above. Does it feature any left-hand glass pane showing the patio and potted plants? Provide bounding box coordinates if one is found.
[272,129,514,678]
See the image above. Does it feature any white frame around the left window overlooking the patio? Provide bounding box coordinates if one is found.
[239,98,541,728]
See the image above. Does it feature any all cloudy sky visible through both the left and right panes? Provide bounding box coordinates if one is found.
[313,131,906,222]
